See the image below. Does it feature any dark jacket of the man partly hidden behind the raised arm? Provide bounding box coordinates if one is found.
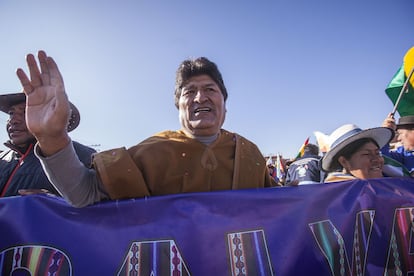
[0,141,96,197]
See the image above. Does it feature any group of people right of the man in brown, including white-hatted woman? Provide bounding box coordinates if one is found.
[268,114,414,186]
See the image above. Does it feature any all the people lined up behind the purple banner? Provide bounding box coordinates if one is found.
[0,51,414,207]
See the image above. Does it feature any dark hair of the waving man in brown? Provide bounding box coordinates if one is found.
[174,57,227,108]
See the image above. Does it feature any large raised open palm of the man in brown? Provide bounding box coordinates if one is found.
[16,51,70,156]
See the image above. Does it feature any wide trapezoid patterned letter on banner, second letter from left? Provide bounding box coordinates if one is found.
[118,240,190,276]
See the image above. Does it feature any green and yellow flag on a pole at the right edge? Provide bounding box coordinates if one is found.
[385,47,414,116]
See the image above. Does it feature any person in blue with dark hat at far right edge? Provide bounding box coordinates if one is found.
[381,114,414,175]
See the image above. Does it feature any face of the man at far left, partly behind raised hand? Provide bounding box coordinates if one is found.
[6,103,34,147]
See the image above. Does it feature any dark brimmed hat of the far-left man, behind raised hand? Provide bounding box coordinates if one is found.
[0,92,80,131]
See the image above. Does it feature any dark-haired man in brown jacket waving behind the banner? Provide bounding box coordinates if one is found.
[17,51,276,207]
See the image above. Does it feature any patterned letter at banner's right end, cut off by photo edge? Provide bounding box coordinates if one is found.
[384,207,414,275]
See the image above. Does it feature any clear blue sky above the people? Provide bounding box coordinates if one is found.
[0,0,414,158]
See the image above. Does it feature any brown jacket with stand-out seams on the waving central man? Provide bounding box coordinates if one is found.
[94,130,276,199]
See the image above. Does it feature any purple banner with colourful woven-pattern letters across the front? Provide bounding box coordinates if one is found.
[0,178,414,276]
